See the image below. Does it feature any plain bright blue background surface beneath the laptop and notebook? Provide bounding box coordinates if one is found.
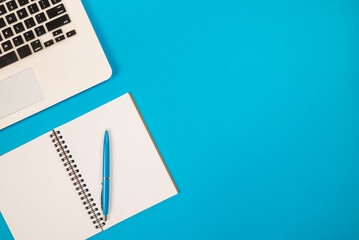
[0,0,359,240]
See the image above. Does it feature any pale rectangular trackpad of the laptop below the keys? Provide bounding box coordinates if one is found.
[0,68,44,119]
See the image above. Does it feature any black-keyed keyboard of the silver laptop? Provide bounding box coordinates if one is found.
[0,0,76,69]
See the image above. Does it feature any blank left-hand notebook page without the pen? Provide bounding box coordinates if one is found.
[0,133,98,240]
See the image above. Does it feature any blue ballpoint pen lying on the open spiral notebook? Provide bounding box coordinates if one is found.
[101,129,110,221]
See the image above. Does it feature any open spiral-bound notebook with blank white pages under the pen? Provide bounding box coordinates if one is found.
[0,94,178,240]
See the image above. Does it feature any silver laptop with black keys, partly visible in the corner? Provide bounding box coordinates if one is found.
[0,0,112,129]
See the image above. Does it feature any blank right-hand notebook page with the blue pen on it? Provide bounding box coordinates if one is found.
[56,94,177,231]
